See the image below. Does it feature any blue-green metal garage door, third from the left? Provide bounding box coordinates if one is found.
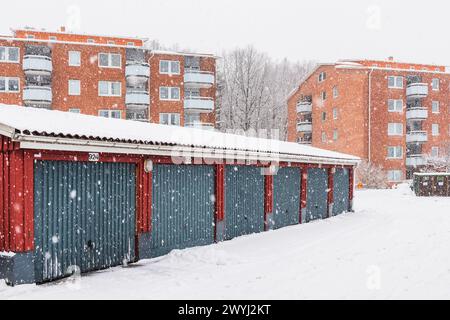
[225,166,264,240]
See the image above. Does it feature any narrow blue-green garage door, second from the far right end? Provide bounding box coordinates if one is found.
[306,169,328,222]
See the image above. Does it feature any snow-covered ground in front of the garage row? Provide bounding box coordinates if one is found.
[0,188,450,299]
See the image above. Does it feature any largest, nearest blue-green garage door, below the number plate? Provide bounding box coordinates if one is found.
[34,161,136,282]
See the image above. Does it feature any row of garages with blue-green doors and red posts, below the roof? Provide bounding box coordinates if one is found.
[0,105,357,285]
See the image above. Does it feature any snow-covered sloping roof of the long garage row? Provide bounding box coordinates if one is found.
[0,104,359,164]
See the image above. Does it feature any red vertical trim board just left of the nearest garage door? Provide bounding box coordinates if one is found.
[23,152,34,251]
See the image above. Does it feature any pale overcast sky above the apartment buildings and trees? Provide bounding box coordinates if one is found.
[0,0,450,65]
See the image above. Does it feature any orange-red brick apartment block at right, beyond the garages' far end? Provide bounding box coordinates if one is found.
[288,58,450,182]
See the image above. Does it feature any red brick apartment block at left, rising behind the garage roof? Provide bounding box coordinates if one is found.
[0,28,216,129]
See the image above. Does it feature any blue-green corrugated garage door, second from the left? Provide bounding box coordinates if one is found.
[151,165,215,257]
